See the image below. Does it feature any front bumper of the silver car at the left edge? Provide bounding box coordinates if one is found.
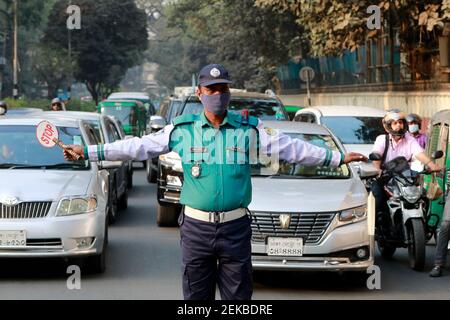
[0,212,106,258]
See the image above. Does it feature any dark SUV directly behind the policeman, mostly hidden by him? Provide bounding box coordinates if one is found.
[156,90,289,226]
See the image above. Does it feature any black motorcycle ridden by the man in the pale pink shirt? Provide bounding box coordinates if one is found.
[369,151,443,271]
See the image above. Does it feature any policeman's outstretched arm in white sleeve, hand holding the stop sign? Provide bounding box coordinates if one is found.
[64,125,173,161]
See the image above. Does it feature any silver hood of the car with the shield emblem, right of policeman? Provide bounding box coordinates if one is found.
[249,177,367,212]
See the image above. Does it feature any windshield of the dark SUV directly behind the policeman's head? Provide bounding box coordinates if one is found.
[183,98,289,121]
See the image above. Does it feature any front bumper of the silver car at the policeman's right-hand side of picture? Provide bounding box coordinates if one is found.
[252,221,375,271]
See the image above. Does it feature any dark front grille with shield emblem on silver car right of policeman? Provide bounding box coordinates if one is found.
[252,212,336,243]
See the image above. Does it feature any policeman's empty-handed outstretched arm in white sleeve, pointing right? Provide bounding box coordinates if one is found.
[258,121,368,167]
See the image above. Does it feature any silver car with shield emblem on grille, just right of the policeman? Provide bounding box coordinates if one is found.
[249,121,374,271]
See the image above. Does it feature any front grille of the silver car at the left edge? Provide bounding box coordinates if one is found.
[0,202,52,219]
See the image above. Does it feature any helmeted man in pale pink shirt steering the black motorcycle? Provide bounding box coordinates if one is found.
[371,110,441,220]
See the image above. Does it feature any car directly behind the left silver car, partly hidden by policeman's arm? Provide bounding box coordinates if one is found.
[43,111,133,224]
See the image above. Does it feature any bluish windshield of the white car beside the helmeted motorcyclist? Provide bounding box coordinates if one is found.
[322,116,385,144]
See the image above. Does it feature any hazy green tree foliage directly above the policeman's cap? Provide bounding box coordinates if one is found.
[152,0,302,91]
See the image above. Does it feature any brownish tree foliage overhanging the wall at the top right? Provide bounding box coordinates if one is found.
[255,0,450,57]
